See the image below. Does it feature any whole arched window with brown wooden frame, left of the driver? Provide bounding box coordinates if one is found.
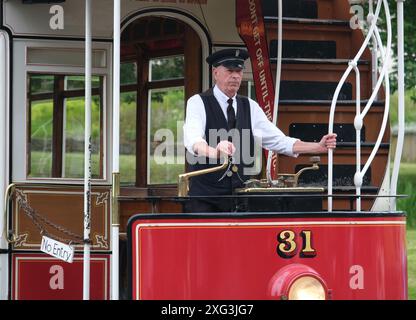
[120,16,203,188]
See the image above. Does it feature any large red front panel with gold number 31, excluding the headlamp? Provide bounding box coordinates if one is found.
[128,213,407,299]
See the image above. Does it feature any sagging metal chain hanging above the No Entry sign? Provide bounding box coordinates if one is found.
[15,190,85,244]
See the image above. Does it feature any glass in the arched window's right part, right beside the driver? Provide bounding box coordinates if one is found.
[147,55,185,185]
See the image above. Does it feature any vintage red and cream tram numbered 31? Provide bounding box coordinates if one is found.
[0,0,407,300]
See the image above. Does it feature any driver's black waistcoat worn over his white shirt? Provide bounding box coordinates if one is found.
[187,89,254,196]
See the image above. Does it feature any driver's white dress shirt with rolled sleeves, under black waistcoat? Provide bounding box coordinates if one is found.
[183,86,299,157]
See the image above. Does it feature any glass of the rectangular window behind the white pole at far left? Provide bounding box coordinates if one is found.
[27,73,103,179]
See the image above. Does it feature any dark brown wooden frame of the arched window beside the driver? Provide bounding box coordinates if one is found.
[120,17,203,197]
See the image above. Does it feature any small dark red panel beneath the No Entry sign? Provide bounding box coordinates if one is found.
[12,253,110,300]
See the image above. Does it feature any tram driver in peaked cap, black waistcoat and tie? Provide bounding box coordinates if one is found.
[184,49,336,212]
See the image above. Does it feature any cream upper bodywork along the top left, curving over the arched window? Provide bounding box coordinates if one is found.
[2,0,241,45]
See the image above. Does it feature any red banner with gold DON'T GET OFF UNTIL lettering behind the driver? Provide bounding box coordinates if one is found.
[236,0,277,177]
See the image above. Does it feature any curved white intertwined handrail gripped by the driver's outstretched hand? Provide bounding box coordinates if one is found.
[328,0,392,212]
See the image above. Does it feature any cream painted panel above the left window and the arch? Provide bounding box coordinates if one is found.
[4,0,241,44]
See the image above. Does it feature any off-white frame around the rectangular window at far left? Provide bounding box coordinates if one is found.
[12,39,112,185]
